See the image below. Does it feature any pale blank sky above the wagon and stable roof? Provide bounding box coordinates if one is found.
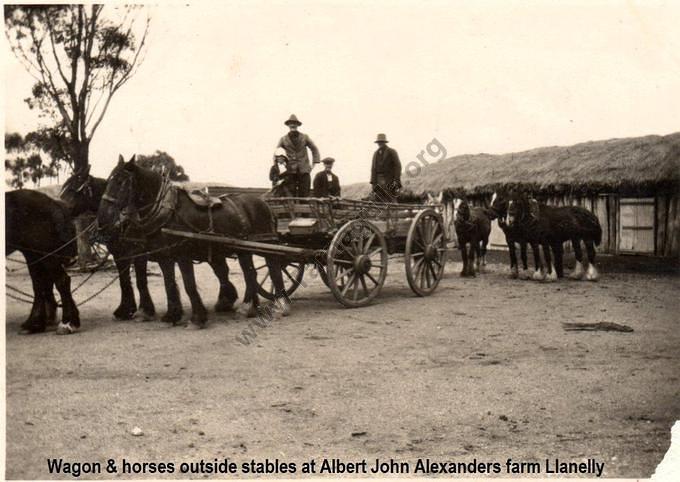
[3,0,680,187]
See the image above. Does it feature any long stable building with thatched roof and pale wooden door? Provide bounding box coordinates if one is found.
[343,133,680,257]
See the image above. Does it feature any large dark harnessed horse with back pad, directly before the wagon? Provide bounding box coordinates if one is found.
[97,156,290,328]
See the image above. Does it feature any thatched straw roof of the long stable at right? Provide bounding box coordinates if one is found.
[343,132,680,198]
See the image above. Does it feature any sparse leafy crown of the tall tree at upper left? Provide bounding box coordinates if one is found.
[4,5,150,170]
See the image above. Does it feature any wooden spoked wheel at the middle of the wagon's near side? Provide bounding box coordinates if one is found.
[326,219,387,308]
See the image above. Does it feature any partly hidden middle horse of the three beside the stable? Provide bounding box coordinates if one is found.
[488,192,543,279]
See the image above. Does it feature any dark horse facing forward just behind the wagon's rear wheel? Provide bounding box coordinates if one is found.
[454,199,491,276]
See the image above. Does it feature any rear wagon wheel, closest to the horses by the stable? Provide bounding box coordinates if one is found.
[404,209,446,296]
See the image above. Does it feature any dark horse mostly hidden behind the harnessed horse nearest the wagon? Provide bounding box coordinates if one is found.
[60,166,156,320]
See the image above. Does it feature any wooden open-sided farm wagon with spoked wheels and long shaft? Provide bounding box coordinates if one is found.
[163,197,447,308]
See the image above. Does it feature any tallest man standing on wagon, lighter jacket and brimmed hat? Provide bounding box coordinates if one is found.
[277,114,319,197]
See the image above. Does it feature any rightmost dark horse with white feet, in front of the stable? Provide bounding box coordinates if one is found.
[508,194,602,281]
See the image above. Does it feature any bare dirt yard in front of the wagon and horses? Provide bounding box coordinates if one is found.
[6,253,680,479]
